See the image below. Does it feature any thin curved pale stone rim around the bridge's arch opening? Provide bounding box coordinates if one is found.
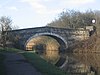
[25,33,68,49]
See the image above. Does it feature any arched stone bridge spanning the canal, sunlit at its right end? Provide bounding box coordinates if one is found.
[8,27,89,50]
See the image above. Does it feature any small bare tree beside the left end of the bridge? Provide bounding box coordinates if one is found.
[0,16,12,47]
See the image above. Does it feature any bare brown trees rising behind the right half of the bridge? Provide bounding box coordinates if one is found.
[47,10,100,34]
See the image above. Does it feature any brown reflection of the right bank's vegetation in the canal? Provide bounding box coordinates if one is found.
[73,52,100,72]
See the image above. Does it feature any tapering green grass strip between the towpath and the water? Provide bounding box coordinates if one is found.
[23,52,69,75]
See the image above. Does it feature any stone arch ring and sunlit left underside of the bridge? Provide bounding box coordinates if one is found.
[25,33,68,50]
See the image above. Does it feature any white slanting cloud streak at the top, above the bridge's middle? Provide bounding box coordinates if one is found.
[22,0,61,14]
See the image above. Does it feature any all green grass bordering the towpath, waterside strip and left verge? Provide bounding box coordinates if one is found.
[0,48,69,75]
